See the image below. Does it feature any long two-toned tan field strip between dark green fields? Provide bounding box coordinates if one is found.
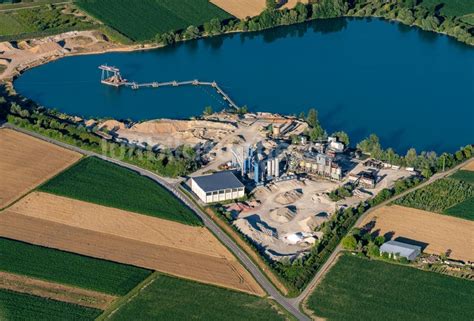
[0,193,264,295]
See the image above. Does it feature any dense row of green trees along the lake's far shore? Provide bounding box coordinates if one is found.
[155,0,474,45]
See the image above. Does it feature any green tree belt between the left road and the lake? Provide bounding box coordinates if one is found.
[0,97,199,177]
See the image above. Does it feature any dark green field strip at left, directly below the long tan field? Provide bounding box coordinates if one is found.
[0,238,151,294]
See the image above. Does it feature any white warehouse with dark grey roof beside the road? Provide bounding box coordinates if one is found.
[191,171,245,203]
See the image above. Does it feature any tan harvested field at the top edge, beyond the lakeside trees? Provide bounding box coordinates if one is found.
[211,0,308,19]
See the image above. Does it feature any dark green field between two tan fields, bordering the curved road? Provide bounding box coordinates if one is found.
[39,157,201,225]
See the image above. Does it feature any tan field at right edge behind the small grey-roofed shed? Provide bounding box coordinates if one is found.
[360,205,474,262]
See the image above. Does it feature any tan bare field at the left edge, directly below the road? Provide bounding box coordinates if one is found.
[0,129,81,208]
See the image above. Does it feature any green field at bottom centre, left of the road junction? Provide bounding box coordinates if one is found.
[108,275,285,321]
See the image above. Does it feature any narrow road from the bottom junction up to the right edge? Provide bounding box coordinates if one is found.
[288,159,474,306]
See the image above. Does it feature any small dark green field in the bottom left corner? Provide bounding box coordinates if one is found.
[0,290,101,321]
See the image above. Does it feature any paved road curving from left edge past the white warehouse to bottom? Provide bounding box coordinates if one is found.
[3,124,310,321]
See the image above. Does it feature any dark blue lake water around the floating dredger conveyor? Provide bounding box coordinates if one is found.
[15,19,474,152]
